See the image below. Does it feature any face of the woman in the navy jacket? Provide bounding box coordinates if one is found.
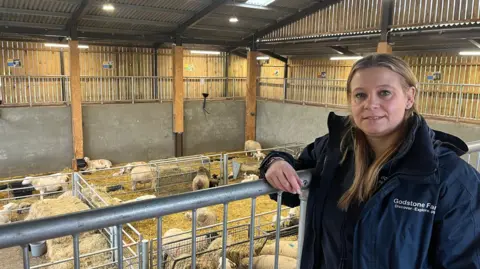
[350,67,415,137]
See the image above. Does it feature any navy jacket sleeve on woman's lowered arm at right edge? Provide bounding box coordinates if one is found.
[433,163,480,269]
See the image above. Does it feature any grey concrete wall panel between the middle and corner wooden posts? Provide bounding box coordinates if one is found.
[184,101,245,155]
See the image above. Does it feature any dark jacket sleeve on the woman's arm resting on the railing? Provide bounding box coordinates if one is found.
[260,135,328,207]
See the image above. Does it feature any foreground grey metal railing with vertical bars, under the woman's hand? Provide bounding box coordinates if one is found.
[0,171,311,269]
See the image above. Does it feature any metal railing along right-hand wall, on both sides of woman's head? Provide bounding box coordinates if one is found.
[257,78,480,120]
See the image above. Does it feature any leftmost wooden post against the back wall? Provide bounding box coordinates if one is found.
[69,40,84,171]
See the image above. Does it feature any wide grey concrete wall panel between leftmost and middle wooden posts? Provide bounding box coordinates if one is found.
[83,103,174,164]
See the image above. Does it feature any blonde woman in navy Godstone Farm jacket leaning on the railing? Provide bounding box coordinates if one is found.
[260,54,480,269]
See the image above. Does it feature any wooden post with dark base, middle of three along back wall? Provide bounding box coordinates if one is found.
[173,46,184,157]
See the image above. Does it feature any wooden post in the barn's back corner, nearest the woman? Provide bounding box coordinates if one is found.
[245,51,259,141]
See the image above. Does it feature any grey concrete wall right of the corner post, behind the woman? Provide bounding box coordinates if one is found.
[257,101,480,147]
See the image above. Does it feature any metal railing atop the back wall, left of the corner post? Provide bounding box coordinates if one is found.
[0,76,247,106]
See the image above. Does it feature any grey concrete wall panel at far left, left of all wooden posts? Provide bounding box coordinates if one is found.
[0,107,73,177]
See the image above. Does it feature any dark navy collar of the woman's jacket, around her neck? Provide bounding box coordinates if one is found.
[328,112,468,180]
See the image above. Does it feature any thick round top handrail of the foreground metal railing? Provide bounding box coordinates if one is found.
[0,170,311,249]
